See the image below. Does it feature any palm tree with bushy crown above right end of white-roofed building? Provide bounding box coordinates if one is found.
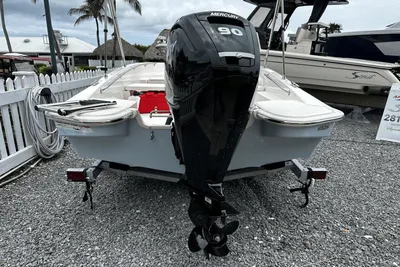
[68,0,114,47]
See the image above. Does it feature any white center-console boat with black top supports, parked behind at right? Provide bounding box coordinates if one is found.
[247,0,400,107]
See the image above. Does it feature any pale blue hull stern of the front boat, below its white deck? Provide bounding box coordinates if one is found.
[58,117,334,174]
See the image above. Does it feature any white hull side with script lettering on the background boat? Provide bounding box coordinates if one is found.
[261,50,400,94]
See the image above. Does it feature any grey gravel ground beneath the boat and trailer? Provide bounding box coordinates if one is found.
[0,109,400,267]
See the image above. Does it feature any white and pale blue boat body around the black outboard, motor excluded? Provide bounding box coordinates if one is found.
[41,62,343,174]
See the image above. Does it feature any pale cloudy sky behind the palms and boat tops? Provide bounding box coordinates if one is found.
[0,0,400,45]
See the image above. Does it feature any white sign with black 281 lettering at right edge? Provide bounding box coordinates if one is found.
[376,83,400,143]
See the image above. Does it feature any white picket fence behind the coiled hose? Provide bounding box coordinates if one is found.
[0,70,103,177]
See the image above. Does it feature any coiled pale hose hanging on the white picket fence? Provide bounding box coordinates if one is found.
[25,86,65,159]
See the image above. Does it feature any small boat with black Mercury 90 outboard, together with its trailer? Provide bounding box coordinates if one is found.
[36,0,344,257]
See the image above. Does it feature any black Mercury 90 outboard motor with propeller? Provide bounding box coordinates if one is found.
[165,12,260,258]
